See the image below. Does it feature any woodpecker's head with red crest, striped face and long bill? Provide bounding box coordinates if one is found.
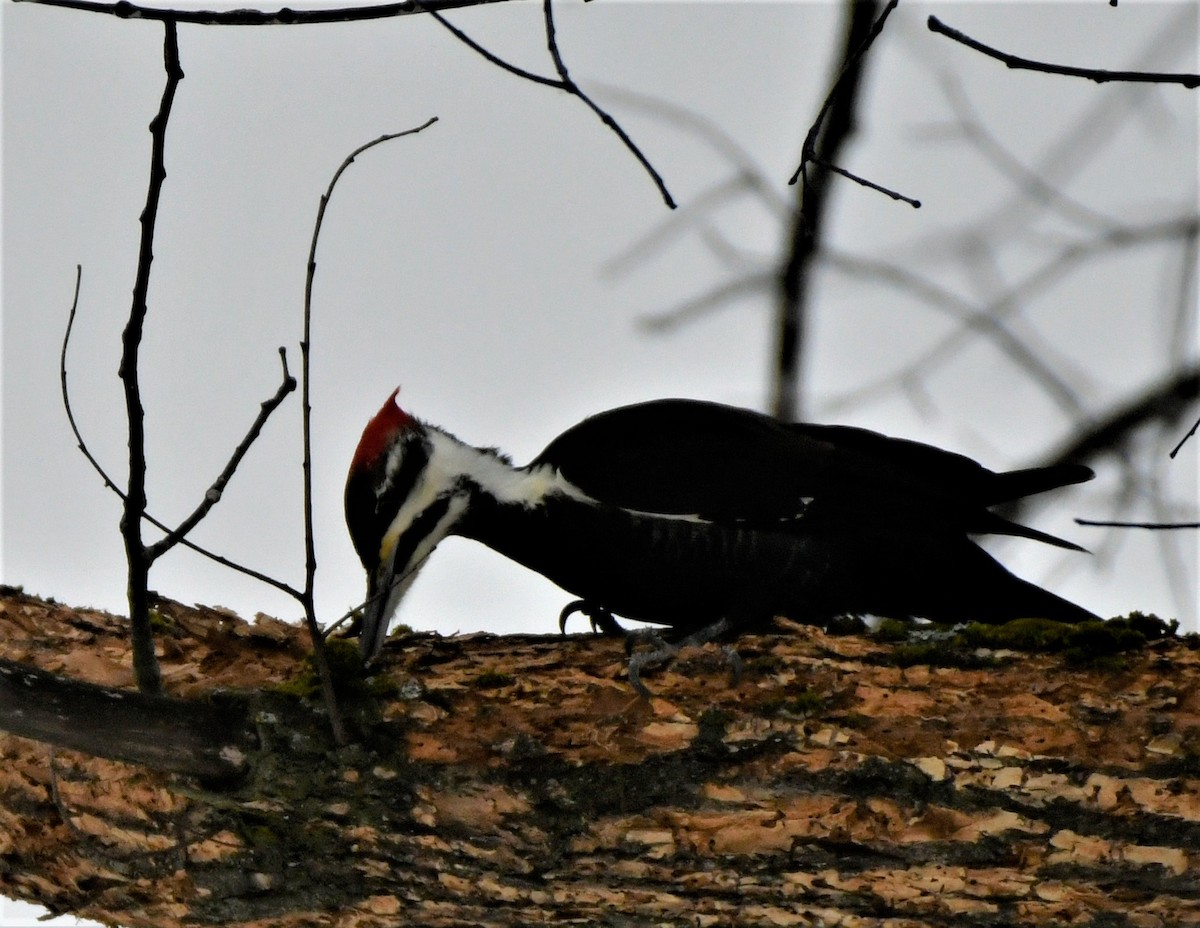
[346,389,470,659]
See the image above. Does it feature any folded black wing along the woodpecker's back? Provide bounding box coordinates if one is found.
[530,400,1091,547]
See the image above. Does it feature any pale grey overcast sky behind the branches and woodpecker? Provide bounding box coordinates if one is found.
[2,0,1198,917]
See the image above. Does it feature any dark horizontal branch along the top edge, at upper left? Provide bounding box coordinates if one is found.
[14,0,516,25]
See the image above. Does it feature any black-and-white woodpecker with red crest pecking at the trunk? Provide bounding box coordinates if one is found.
[346,391,1097,687]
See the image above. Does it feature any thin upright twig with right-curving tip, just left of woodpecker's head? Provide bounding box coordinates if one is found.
[299,116,438,744]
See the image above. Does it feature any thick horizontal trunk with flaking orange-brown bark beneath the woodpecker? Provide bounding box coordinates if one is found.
[0,591,1200,928]
